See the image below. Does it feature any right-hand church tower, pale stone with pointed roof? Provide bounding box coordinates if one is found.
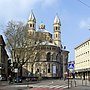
[53,15,61,48]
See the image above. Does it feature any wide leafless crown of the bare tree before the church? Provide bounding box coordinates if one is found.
[4,21,45,76]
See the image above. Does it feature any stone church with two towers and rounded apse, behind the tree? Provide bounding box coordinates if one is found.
[22,12,69,78]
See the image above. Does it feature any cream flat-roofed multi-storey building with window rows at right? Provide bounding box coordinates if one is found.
[75,39,90,79]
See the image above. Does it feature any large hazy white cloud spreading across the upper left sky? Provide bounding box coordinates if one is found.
[0,0,58,20]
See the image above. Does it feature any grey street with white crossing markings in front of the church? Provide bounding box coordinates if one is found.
[0,79,90,90]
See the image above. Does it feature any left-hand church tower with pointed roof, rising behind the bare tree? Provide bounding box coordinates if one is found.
[28,11,36,36]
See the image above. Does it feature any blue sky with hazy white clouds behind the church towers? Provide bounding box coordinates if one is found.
[0,0,90,60]
